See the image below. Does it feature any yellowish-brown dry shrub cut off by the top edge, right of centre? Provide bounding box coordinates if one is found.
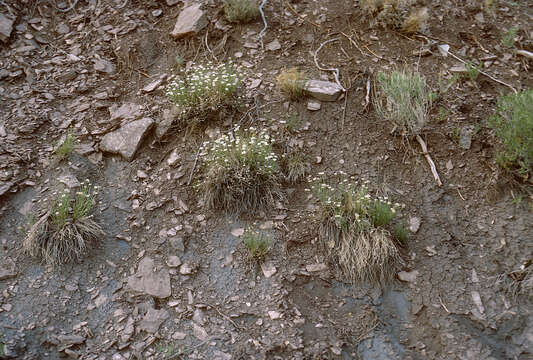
[361,0,429,34]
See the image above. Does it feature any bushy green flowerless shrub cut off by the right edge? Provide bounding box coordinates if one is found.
[488,89,533,181]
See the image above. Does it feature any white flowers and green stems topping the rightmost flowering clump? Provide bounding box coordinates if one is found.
[306,171,402,229]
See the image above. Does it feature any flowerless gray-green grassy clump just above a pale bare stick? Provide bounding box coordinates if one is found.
[374,71,434,135]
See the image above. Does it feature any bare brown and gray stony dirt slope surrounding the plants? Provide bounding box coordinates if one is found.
[0,0,533,360]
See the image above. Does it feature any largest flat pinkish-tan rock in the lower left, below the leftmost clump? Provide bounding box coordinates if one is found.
[128,257,171,299]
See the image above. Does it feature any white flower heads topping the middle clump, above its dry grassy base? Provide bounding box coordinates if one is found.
[200,127,279,175]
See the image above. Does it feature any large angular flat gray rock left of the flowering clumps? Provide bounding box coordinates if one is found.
[100,118,154,161]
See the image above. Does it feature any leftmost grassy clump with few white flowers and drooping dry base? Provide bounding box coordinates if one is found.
[22,180,105,265]
